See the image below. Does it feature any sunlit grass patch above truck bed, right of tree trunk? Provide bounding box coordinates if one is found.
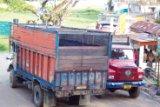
[63,9,100,28]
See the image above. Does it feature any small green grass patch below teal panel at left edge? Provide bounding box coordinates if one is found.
[0,36,9,52]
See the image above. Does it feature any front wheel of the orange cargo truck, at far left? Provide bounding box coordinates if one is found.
[9,69,18,88]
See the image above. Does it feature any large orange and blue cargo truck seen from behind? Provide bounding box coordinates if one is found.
[8,23,112,107]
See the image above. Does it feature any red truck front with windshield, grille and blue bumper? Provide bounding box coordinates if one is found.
[107,44,144,98]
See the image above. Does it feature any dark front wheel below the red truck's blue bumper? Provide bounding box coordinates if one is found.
[129,87,140,98]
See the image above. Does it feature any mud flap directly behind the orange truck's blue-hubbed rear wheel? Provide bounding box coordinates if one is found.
[43,92,56,107]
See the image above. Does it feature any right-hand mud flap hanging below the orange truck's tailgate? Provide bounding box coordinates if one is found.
[79,95,91,106]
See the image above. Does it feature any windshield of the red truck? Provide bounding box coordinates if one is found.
[111,49,133,60]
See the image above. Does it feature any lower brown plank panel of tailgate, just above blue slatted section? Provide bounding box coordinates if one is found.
[56,56,108,71]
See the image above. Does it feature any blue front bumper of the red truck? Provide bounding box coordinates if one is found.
[106,81,145,89]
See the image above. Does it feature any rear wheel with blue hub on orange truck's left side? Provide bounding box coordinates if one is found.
[33,85,44,107]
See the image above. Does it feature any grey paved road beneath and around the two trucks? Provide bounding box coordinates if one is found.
[0,54,160,107]
